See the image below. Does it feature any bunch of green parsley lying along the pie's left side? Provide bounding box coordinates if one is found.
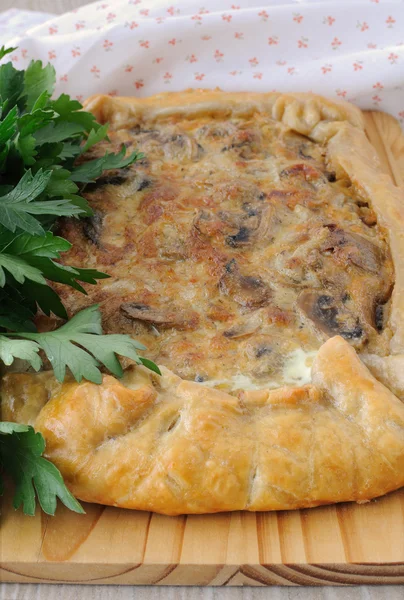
[0,46,159,515]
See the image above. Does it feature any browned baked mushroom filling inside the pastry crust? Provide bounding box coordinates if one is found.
[59,113,394,392]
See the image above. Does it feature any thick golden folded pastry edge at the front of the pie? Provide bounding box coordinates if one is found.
[3,336,404,515]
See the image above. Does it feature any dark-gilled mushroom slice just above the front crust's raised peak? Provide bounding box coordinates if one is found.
[297,290,367,345]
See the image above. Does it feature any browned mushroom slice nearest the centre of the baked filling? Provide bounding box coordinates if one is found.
[219,259,272,308]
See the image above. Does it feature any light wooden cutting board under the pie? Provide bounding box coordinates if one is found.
[0,112,404,585]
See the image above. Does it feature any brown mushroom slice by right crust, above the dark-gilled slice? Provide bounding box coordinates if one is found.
[321,224,383,273]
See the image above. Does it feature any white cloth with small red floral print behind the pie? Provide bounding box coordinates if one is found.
[0,0,404,125]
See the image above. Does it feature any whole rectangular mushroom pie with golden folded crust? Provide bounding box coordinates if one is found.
[3,91,404,514]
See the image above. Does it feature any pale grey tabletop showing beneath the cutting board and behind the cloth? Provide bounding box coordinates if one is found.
[0,0,404,600]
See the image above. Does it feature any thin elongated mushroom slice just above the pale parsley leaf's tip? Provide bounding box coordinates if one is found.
[120,302,199,329]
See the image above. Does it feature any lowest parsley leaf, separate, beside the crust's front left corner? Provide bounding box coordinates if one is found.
[0,422,84,516]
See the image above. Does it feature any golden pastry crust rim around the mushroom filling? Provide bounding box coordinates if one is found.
[3,90,404,514]
